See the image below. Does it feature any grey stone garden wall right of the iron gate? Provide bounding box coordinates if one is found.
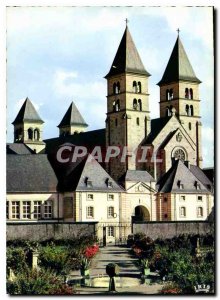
[133,221,213,239]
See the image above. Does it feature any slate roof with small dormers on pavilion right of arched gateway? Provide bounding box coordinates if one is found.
[157,160,210,194]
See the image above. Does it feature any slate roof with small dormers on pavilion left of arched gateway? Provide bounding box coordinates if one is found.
[50,155,123,192]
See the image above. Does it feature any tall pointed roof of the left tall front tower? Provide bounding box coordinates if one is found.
[105,26,150,78]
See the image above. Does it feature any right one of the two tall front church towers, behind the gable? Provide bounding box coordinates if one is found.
[158,34,202,167]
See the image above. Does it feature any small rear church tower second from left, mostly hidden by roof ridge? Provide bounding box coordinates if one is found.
[57,102,88,136]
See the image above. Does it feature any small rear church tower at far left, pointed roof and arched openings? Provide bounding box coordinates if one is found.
[12,98,45,153]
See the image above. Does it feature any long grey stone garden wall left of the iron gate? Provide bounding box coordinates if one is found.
[6,222,97,241]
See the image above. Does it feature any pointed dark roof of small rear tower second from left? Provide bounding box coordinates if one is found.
[57,102,88,127]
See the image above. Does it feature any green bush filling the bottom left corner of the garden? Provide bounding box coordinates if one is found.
[7,269,74,295]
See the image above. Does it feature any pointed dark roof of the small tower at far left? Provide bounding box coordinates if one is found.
[12,98,44,125]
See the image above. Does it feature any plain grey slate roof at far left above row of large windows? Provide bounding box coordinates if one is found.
[7,154,58,193]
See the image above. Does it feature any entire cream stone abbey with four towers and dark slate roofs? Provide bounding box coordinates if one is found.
[7,26,214,242]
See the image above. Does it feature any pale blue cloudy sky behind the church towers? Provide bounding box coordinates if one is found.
[7,7,214,167]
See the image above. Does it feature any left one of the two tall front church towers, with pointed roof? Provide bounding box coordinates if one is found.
[105,25,150,180]
